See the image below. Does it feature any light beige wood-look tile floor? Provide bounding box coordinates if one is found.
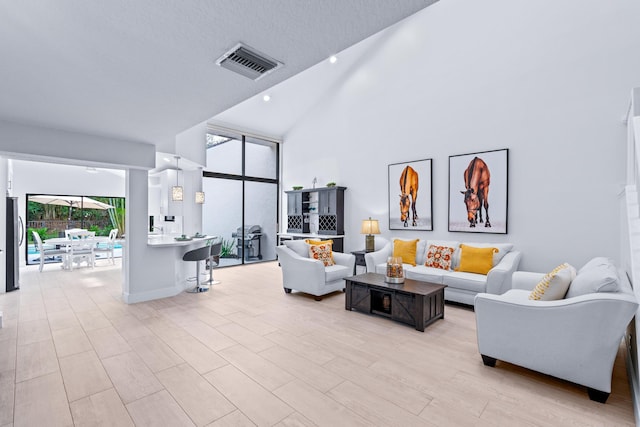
[0,263,634,427]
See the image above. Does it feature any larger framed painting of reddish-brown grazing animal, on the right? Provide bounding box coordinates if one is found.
[449,148,509,234]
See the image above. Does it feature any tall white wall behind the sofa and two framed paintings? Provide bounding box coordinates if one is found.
[282,0,640,271]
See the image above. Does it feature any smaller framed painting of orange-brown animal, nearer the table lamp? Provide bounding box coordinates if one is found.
[389,159,433,230]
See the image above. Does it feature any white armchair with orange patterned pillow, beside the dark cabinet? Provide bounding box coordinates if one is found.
[276,240,356,301]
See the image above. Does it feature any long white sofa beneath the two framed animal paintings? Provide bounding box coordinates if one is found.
[365,239,522,305]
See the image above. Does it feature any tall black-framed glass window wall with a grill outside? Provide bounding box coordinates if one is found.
[202,132,279,266]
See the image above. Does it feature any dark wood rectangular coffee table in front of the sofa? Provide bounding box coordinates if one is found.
[344,273,446,332]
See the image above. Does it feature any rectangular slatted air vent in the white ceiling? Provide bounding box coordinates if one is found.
[216,43,282,80]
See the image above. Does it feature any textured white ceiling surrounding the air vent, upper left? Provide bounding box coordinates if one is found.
[0,0,435,152]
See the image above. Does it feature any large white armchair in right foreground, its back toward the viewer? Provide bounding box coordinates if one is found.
[475,265,638,403]
